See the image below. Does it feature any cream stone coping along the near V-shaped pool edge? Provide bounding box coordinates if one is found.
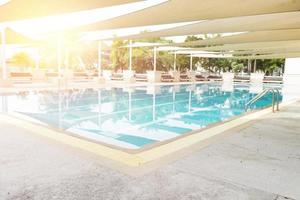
[0,99,299,167]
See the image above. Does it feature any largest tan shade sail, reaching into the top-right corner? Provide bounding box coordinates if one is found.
[82,0,300,30]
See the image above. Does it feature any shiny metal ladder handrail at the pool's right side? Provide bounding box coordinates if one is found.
[245,88,280,113]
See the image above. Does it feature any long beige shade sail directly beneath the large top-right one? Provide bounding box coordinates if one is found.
[120,12,300,39]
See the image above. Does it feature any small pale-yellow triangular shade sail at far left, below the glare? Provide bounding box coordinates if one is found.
[0,28,35,44]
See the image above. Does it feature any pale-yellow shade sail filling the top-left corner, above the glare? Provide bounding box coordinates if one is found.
[0,0,138,22]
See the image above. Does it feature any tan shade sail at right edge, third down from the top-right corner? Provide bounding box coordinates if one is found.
[176,29,300,47]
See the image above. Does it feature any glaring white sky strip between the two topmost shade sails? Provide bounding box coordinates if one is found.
[10,0,167,37]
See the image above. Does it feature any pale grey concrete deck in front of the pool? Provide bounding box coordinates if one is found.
[0,102,300,200]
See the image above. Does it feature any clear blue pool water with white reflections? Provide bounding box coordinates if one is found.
[1,83,282,149]
